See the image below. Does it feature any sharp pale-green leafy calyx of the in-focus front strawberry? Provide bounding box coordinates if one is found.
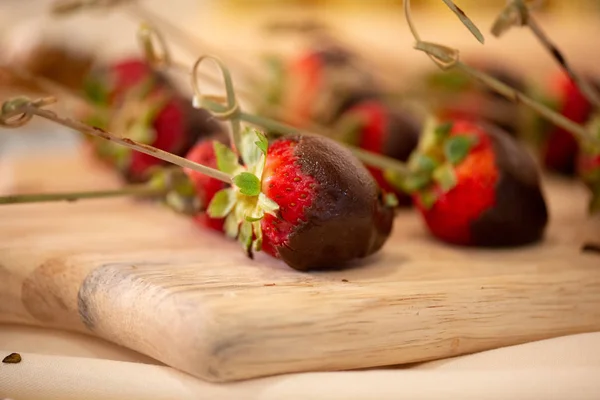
[207,128,279,257]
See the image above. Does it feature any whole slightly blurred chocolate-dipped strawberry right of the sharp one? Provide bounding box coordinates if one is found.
[394,120,548,247]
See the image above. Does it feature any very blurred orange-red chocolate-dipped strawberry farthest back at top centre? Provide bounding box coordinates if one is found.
[260,44,376,128]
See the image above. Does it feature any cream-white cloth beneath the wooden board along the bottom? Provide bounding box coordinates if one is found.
[0,325,600,400]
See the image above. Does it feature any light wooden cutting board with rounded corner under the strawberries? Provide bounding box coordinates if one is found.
[0,148,600,382]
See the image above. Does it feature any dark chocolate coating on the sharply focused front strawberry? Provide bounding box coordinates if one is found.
[278,136,394,271]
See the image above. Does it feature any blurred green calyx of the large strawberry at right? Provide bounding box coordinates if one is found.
[385,119,477,208]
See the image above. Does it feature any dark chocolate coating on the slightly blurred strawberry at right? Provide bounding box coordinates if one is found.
[471,123,548,247]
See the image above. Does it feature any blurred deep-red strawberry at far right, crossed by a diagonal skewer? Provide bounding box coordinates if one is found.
[538,72,593,175]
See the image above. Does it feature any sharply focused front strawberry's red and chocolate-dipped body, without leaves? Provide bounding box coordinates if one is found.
[261,136,393,270]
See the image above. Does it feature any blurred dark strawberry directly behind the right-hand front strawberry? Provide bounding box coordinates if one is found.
[426,62,525,136]
